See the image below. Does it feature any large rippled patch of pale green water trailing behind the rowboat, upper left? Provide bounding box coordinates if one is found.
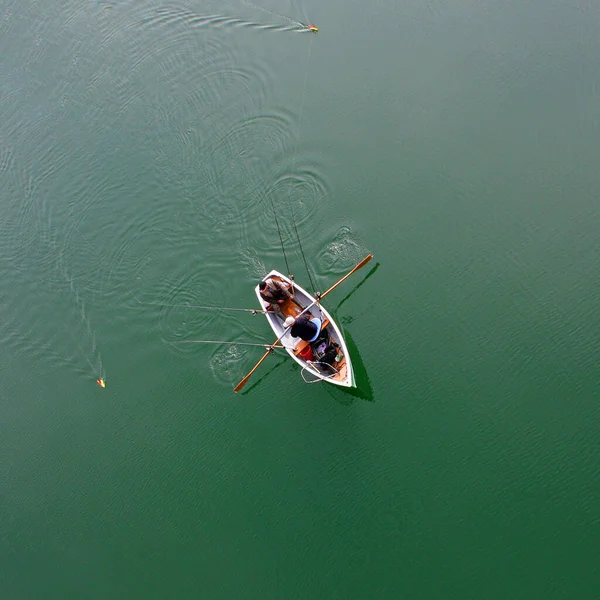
[0,3,329,384]
